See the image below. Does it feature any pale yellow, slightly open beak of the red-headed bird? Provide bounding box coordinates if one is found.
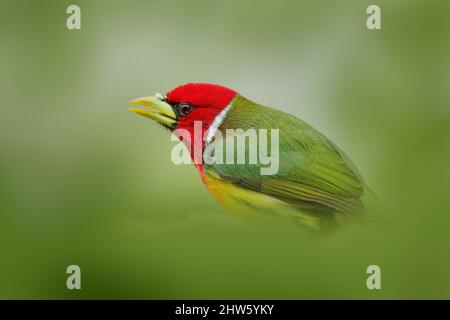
[128,94,178,129]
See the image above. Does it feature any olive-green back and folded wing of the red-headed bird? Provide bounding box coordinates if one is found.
[204,96,365,213]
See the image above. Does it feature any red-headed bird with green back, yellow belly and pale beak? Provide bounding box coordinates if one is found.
[129,83,378,232]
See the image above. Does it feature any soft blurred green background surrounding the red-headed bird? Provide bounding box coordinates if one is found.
[0,0,450,299]
